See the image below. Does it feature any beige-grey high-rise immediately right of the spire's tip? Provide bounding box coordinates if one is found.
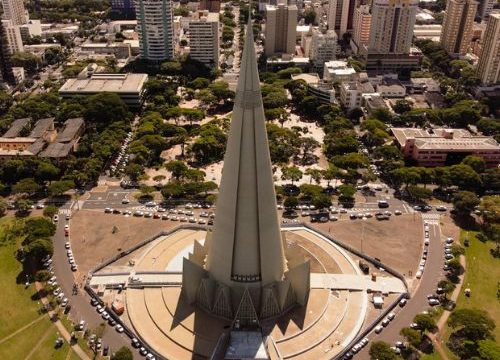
[264,4,297,56]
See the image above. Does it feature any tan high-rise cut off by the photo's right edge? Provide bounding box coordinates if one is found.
[477,13,500,85]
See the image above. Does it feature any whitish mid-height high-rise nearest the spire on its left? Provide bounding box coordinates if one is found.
[189,11,219,68]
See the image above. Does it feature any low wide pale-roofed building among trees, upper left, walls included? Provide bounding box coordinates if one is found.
[59,73,148,108]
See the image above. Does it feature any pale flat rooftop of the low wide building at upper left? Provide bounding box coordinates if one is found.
[59,74,148,93]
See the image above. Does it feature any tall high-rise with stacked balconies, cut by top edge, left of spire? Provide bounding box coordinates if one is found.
[135,0,174,62]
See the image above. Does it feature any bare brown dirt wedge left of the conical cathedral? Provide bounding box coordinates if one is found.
[71,210,178,273]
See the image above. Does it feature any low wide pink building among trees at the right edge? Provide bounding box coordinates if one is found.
[391,128,500,167]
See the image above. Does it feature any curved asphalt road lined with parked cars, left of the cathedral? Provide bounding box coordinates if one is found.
[52,214,142,359]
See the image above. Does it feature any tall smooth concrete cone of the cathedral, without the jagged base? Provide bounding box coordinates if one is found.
[207,11,285,286]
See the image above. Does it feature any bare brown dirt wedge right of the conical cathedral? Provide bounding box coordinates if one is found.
[313,215,423,275]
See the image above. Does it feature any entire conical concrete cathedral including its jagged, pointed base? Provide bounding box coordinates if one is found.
[183,13,309,324]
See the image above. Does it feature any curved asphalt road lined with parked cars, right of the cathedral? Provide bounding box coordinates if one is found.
[355,221,444,359]
